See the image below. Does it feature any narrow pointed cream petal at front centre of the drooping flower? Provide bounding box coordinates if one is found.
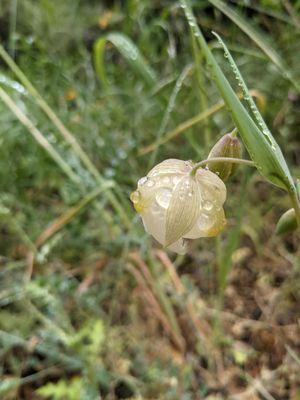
[165,175,201,246]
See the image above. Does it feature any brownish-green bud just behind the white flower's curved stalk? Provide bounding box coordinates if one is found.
[207,133,242,181]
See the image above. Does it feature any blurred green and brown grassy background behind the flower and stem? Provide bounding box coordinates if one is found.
[0,0,300,400]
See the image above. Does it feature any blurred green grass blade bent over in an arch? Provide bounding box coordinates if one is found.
[94,32,156,87]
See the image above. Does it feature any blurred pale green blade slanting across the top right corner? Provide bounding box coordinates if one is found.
[209,0,300,91]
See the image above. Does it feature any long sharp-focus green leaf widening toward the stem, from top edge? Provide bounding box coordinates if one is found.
[181,0,295,192]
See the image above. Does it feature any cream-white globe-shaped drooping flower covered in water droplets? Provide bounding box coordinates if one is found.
[130,159,226,254]
